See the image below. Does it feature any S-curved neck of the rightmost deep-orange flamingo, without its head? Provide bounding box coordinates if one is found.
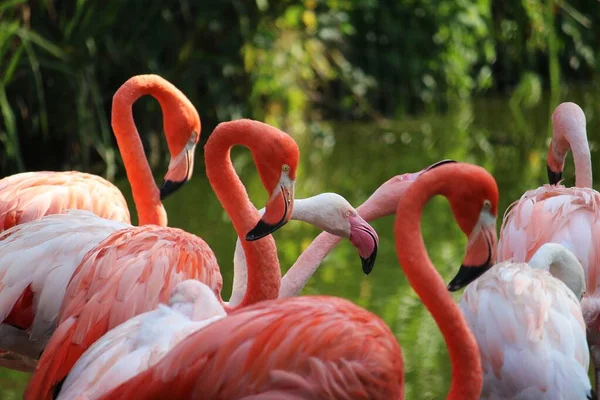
[394,177,482,400]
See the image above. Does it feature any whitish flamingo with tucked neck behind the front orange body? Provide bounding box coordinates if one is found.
[57,280,225,400]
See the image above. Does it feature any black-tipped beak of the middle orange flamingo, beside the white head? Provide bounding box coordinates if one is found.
[246,173,294,241]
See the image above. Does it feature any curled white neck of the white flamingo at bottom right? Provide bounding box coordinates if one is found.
[528,243,585,298]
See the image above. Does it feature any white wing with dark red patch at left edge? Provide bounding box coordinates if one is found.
[0,210,128,365]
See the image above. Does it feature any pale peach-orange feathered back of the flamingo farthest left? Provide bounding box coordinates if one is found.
[0,171,130,230]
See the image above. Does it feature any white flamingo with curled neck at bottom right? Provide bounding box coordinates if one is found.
[460,243,597,400]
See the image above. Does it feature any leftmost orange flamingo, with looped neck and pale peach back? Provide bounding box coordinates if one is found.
[0,75,200,232]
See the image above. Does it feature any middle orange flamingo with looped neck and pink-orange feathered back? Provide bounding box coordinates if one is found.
[24,120,299,400]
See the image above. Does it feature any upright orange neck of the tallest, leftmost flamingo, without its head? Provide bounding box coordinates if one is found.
[111,76,173,226]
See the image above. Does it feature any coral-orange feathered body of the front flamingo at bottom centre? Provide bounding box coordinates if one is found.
[96,296,403,400]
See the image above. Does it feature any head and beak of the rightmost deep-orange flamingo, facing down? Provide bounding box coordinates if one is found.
[448,166,499,291]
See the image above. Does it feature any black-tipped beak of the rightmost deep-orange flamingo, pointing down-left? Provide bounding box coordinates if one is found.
[448,209,497,292]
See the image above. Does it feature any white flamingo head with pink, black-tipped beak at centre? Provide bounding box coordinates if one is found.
[292,193,379,274]
